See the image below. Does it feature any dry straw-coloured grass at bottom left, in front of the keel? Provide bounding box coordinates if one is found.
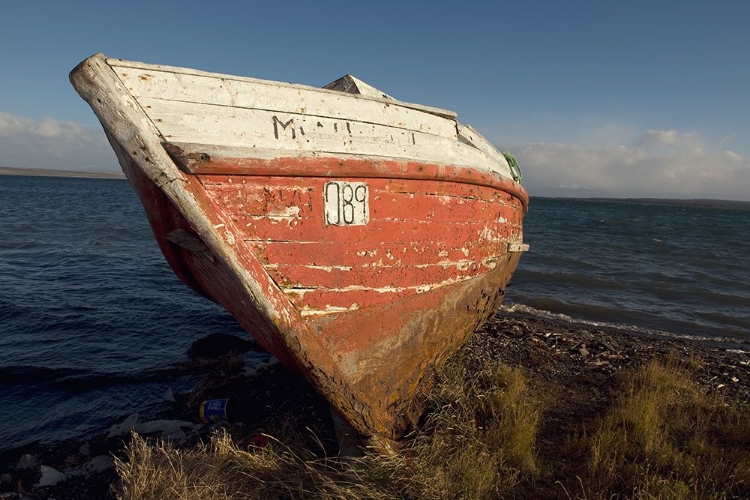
[115,432,396,500]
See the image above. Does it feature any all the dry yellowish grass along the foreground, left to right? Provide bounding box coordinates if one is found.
[117,359,750,500]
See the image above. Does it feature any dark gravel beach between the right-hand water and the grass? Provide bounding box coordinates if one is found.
[467,315,750,455]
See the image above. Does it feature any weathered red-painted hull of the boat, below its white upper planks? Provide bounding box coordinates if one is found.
[131,144,525,439]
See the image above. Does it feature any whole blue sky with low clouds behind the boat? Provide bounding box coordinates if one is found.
[0,0,750,200]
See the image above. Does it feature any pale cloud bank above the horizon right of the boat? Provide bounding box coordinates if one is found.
[514,130,750,200]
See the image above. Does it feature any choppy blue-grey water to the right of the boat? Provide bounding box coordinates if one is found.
[505,198,750,342]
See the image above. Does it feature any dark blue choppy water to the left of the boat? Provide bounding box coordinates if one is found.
[0,176,256,450]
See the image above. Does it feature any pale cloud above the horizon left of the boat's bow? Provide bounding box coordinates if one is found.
[0,111,118,171]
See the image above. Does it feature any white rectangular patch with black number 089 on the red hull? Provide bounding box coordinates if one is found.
[323,182,370,226]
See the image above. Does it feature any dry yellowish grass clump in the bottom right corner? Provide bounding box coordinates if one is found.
[581,358,750,499]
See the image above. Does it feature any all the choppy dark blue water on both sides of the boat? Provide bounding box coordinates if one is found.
[0,176,750,450]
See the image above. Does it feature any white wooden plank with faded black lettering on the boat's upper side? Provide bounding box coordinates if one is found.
[139,98,510,172]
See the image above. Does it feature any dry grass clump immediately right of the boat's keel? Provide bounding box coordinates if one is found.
[399,364,541,499]
